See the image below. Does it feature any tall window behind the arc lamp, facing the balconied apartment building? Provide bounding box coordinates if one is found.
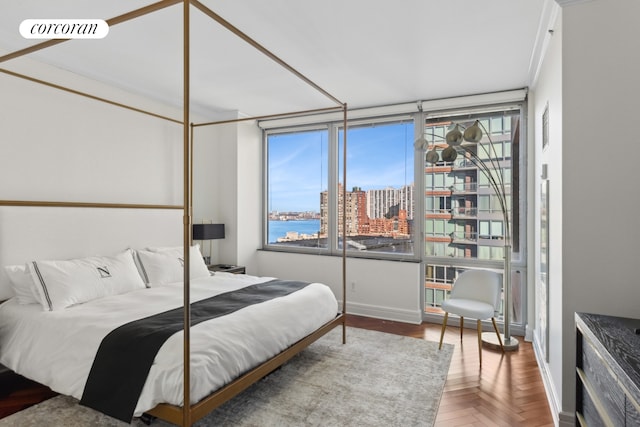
[424,105,526,330]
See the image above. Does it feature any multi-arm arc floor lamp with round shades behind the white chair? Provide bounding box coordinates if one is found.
[415,120,518,350]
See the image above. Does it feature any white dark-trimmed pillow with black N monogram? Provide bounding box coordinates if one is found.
[29,249,145,311]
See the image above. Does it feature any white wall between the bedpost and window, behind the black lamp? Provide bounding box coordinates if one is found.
[193,117,262,274]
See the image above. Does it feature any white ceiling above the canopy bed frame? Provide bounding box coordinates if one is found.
[0,0,549,116]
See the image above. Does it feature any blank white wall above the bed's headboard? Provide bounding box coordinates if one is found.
[0,61,182,204]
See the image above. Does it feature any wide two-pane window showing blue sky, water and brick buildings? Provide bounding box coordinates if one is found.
[265,120,416,258]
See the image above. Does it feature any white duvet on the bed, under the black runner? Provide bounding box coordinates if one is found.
[0,273,338,416]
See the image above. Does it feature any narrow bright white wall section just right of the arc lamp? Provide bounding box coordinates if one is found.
[530,3,563,421]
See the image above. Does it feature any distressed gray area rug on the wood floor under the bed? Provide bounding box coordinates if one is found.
[0,328,453,427]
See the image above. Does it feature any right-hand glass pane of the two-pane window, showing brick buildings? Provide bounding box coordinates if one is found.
[337,121,416,255]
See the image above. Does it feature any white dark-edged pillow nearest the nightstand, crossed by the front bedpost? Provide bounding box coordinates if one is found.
[136,245,211,286]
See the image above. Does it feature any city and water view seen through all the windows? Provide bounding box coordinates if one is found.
[268,110,520,318]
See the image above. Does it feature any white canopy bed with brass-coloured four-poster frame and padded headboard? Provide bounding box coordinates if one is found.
[0,0,348,426]
